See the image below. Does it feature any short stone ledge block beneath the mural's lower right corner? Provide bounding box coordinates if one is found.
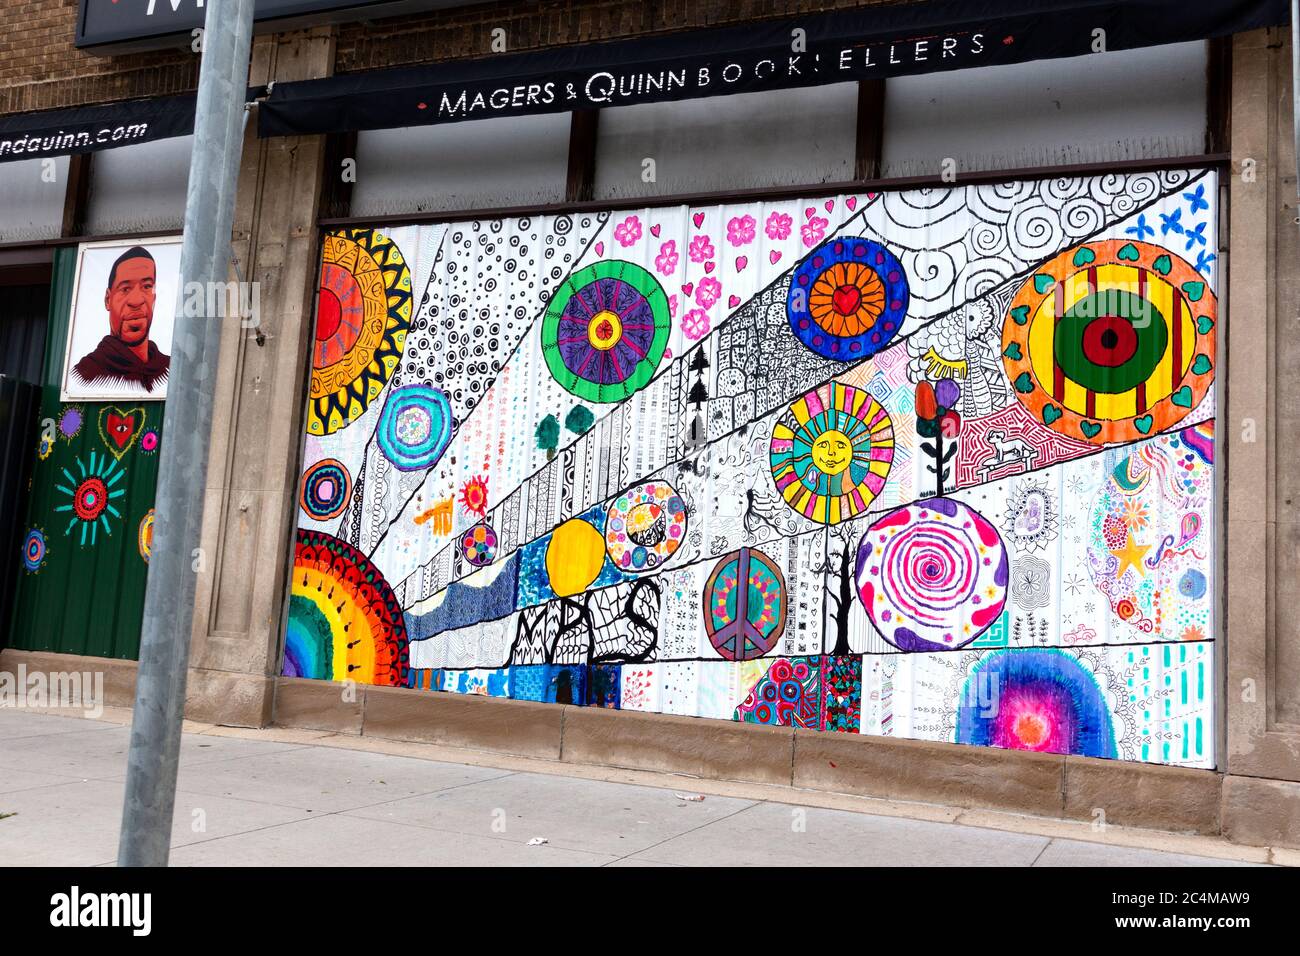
[1065,757,1222,834]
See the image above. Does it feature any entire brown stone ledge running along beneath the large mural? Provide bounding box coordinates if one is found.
[263,678,1300,847]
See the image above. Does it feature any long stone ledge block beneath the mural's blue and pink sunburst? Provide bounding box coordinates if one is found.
[794,730,1065,817]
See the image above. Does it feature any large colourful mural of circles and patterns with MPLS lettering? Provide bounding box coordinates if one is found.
[283,170,1218,767]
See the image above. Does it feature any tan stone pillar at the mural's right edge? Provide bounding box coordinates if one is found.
[1218,22,1300,847]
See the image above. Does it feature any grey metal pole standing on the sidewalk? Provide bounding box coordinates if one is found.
[117,0,254,866]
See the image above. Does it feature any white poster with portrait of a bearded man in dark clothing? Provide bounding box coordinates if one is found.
[61,238,181,401]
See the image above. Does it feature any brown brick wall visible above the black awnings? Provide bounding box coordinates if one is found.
[0,0,900,114]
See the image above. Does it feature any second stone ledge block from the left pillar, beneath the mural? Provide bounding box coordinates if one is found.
[366,687,564,760]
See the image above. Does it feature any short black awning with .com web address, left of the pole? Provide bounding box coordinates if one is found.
[0,92,195,163]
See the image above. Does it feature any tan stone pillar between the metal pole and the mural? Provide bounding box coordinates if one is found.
[186,27,334,727]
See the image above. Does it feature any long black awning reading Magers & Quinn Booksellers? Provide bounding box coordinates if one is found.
[257,0,1290,137]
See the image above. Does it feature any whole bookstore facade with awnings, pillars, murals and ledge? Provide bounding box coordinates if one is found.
[0,0,1300,845]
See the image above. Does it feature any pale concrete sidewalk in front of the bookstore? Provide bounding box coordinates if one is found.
[0,710,1284,866]
